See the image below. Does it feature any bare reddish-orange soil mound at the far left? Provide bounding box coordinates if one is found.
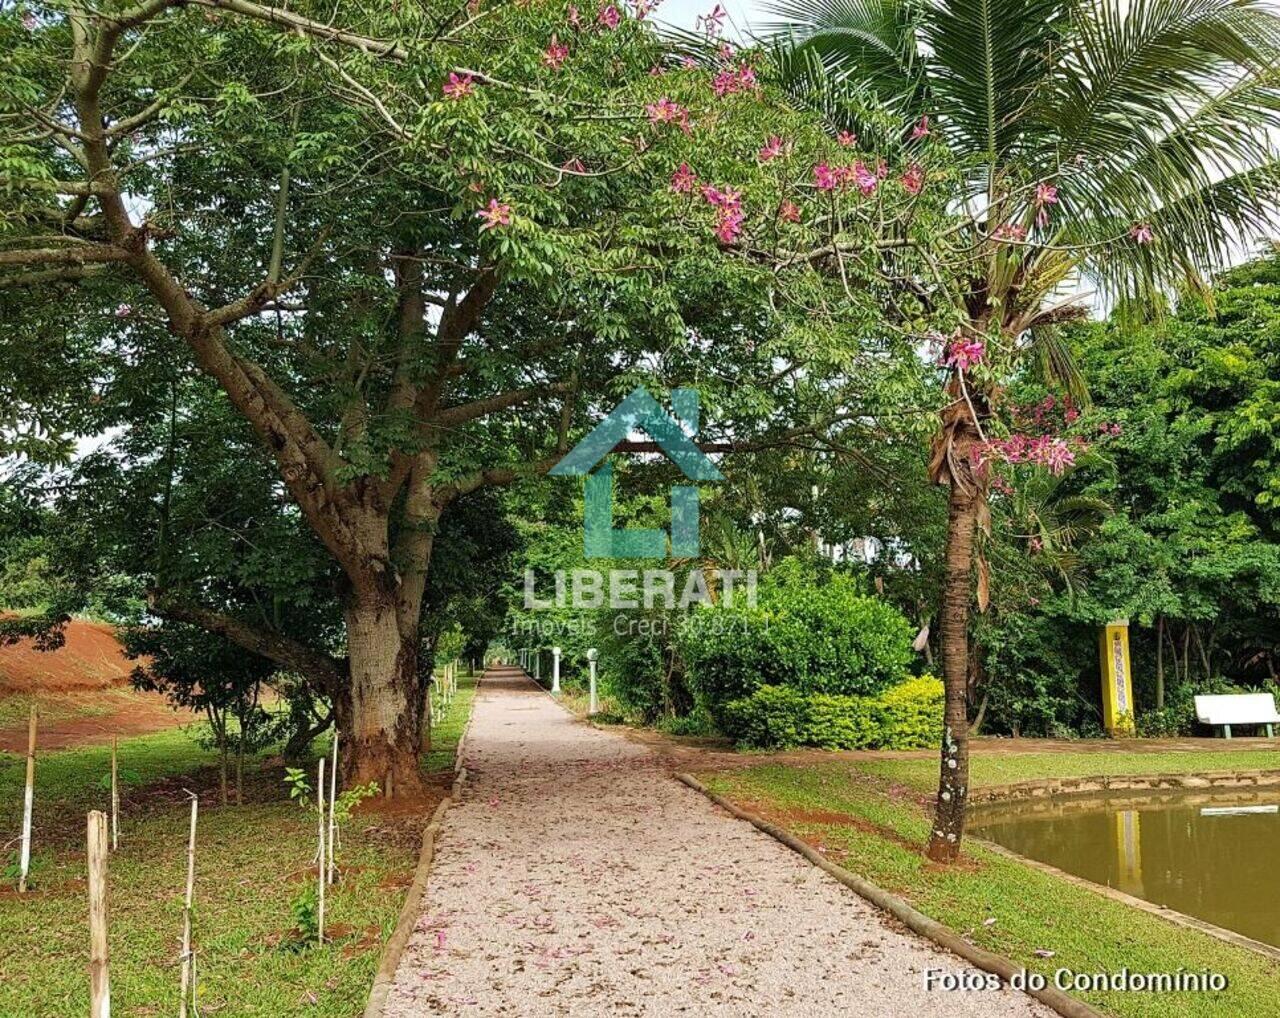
[0,620,137,697]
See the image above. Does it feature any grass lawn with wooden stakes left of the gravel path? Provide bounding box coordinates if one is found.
[0,677,474,1018]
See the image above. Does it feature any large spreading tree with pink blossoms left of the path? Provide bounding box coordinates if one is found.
[0,0,928,794]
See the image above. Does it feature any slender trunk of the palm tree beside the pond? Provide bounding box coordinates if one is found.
[927,481,982,863]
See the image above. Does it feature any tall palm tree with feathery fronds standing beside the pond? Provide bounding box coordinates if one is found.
[767,0,1280,860]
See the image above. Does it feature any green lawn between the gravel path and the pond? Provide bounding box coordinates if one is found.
[698,753,1280,1018]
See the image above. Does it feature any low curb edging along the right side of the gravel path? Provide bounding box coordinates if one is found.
[676,772,1105,1018]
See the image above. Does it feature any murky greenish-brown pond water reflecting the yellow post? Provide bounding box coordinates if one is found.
[970,793,1280,946]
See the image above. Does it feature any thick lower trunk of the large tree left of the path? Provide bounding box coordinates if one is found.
[343,595,425,798]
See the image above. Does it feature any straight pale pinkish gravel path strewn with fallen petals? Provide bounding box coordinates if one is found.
[384,670,1052,1018]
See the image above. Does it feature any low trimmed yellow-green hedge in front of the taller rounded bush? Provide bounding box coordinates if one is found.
[721,675,943,749]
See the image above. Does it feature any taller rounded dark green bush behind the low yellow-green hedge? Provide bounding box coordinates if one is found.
[678,576,913,722]
